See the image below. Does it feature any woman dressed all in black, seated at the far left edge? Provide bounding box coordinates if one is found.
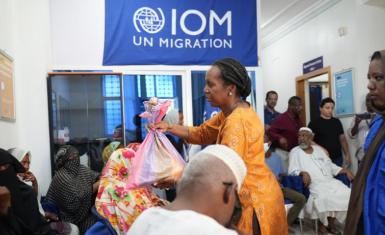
[0,149,73,234]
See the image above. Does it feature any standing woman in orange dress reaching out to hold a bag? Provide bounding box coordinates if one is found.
[150,58,288,235]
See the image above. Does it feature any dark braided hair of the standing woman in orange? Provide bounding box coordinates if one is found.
[213,58,251,99]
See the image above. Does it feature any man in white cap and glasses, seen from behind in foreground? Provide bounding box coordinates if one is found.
[127,145,246,235]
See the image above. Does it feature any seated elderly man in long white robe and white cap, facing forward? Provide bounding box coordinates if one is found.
[288,127,353,234]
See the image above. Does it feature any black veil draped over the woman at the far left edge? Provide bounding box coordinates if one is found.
[0,149,43,231]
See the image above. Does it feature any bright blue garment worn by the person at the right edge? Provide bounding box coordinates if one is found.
[363,115,385,235]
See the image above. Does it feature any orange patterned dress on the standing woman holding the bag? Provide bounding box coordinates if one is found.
[186,108,288,235]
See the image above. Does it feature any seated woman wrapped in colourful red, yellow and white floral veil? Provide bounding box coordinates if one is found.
[95,145,164,234]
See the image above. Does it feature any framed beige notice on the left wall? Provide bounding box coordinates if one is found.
[0,50,15,121]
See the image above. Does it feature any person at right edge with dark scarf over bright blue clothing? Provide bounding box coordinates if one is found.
[344,50,385,235]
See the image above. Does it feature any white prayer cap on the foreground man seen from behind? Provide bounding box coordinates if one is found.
[194,144,247,192]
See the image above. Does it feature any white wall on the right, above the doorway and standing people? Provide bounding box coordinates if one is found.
[261,0,385,172]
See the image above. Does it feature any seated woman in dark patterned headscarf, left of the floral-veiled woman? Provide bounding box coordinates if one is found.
[47,145,99,234]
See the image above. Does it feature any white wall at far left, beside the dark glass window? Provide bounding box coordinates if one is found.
[0,0,51,194]
